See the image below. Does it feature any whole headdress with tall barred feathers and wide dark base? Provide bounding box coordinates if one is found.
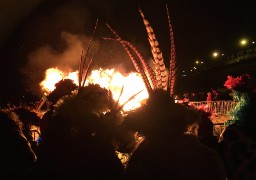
[104,5,204,138]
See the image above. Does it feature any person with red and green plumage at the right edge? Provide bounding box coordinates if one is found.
[219,74,256,180]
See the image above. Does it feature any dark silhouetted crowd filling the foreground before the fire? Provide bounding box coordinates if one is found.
[0,75,256,180]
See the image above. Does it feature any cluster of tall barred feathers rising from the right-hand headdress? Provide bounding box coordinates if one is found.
[107,5,177,97]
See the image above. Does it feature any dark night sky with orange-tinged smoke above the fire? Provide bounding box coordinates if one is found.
[0,0,256,105]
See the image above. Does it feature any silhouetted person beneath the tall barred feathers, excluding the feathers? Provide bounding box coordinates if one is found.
[124,90,226,180]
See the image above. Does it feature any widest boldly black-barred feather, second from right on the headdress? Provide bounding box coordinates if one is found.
[139,9,167,90]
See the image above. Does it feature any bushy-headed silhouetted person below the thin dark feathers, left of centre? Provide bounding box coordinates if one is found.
[37,84,137,180]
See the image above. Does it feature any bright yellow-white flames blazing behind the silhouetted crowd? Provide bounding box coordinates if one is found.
[40,68,148,111]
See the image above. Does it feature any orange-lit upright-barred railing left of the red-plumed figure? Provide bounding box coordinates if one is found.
[189,101,238,115]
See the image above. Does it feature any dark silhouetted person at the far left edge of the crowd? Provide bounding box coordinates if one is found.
[0,109,37,179]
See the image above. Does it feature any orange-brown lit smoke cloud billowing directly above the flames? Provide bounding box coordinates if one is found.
[21,29,134,94]
